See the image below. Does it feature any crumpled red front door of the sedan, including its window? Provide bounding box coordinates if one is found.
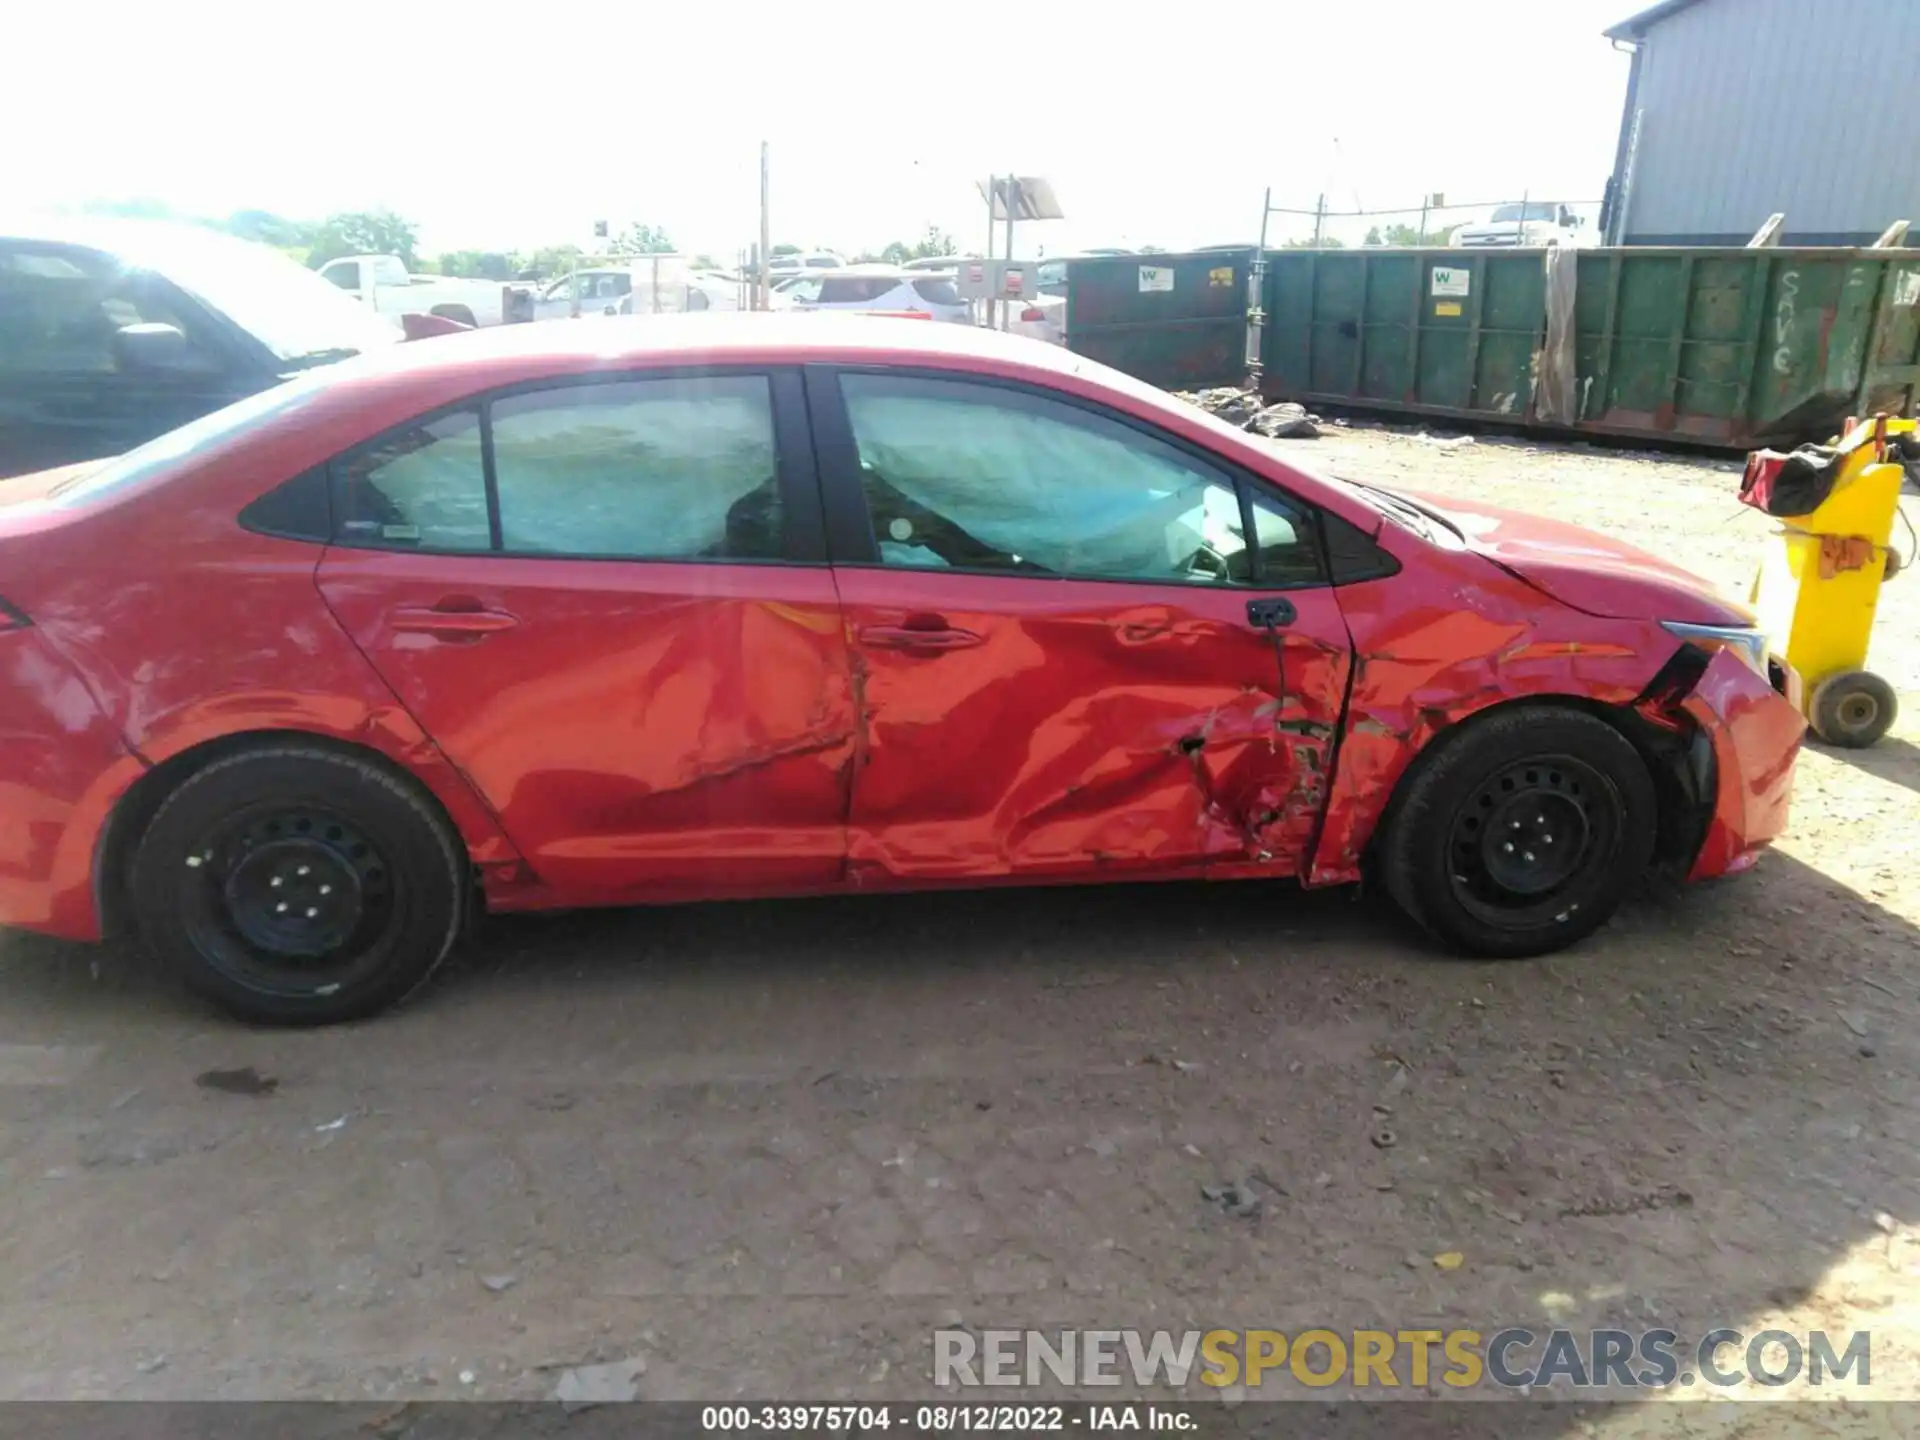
[808,371,1350,883]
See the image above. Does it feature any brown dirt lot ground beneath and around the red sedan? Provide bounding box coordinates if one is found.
[0,428,1920,1400]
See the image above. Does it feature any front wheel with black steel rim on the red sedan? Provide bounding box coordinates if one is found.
[1380,705,1659,960]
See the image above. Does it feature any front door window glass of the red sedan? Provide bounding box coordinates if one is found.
[841,374,1252,586]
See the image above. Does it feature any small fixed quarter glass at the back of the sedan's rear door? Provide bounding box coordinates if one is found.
[334,411,492,551]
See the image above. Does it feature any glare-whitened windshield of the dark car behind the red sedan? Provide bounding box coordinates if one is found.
[140,234,405,361]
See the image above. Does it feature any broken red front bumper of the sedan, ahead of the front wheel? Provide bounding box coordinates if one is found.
[1682,651,1807,879]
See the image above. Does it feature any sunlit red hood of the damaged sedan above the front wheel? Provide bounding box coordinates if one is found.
[1407,493,1755,626]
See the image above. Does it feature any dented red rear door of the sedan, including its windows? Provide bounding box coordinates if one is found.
[319,371,856,904]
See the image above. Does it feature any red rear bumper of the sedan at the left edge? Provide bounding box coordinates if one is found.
[0,630,146,941]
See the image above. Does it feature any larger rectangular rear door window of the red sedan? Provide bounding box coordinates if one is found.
[492,376,781,561]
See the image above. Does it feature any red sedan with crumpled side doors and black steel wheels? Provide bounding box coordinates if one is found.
[0,315,1801,1023]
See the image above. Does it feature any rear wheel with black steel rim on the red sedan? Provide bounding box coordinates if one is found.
[129,745,470,1025]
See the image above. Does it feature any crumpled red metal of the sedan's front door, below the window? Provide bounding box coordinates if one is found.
[839,570,1348,885]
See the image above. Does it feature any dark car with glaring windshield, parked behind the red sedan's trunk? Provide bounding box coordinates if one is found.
[0,219,412,476]
